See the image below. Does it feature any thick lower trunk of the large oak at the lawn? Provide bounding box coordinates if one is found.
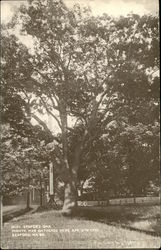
[62,181,78,216]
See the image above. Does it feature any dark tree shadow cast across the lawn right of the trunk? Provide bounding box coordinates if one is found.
[78,207,161,237]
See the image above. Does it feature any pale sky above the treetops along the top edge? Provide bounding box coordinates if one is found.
[1,0,159,23]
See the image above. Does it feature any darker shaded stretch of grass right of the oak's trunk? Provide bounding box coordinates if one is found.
[80,205,161,236]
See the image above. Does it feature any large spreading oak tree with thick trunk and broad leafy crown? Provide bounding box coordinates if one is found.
[1,0,158,214]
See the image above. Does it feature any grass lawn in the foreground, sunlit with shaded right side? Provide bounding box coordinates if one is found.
[2,206,161,249]
